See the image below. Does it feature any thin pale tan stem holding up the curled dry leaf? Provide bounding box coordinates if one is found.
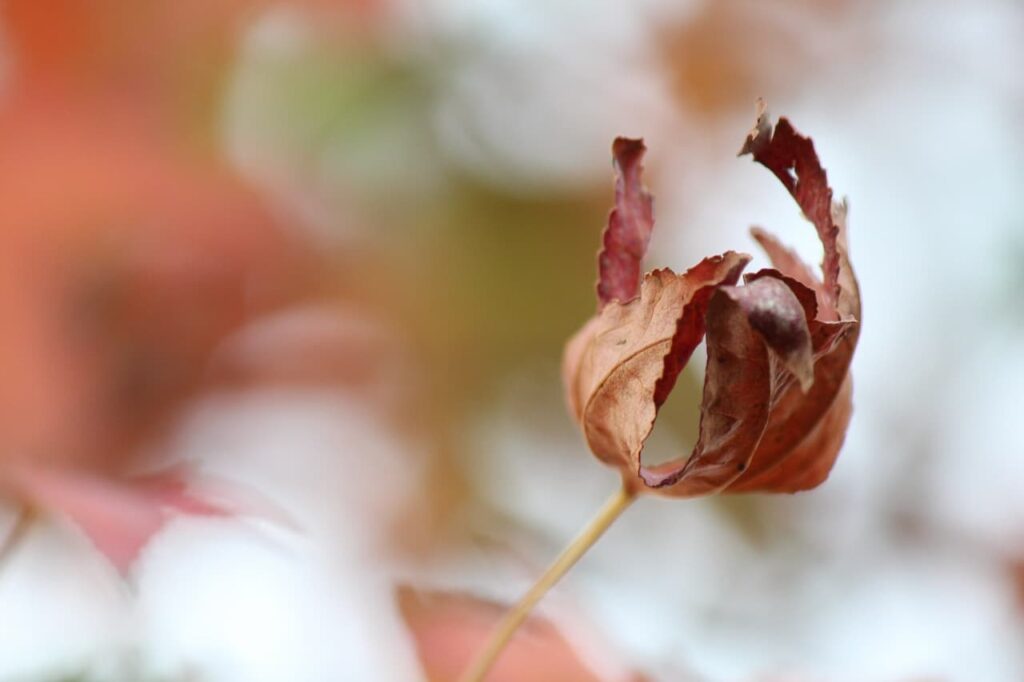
[459,485,636,682]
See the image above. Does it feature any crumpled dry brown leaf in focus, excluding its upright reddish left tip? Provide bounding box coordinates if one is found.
[563,102,860,497]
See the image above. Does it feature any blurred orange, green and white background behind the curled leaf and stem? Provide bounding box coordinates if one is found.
[0,0,1024,682]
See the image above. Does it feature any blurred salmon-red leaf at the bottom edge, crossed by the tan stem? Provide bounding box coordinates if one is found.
[398,588,643,682]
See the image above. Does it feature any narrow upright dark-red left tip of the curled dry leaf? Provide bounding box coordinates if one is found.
[597,137,654,305]
